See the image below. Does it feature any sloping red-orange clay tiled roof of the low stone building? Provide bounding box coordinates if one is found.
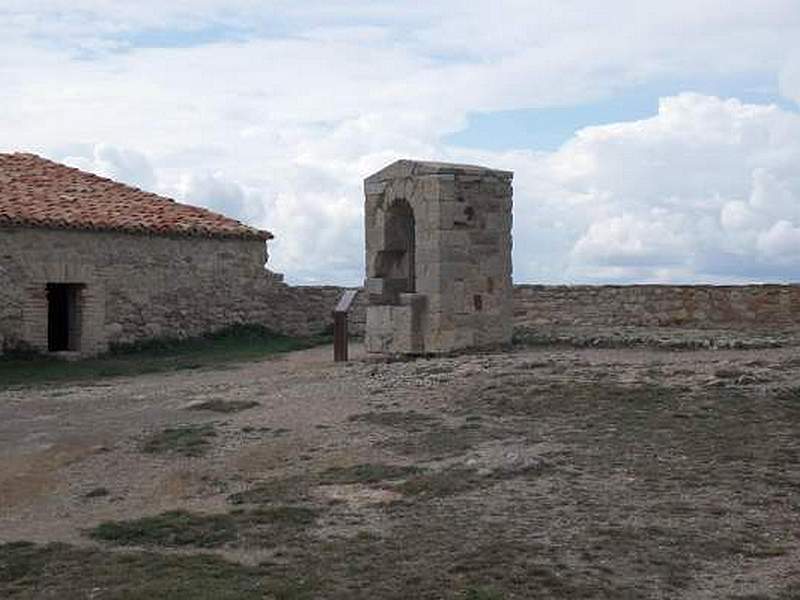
[0,153,272,240]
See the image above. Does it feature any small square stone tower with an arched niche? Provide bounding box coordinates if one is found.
[364,160,513,354]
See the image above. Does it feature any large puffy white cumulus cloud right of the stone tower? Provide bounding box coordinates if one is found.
[500,94,800,281]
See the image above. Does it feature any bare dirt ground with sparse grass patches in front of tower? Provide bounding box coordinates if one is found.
[0,340,800,600]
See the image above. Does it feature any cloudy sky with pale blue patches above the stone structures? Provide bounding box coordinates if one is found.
[0,0,800,285]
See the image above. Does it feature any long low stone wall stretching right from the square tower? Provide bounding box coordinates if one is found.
[514,285,800,329]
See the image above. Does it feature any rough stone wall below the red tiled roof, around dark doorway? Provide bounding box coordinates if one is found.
[0,228,356,354]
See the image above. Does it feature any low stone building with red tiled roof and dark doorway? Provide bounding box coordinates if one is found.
[0,153,328,355]
